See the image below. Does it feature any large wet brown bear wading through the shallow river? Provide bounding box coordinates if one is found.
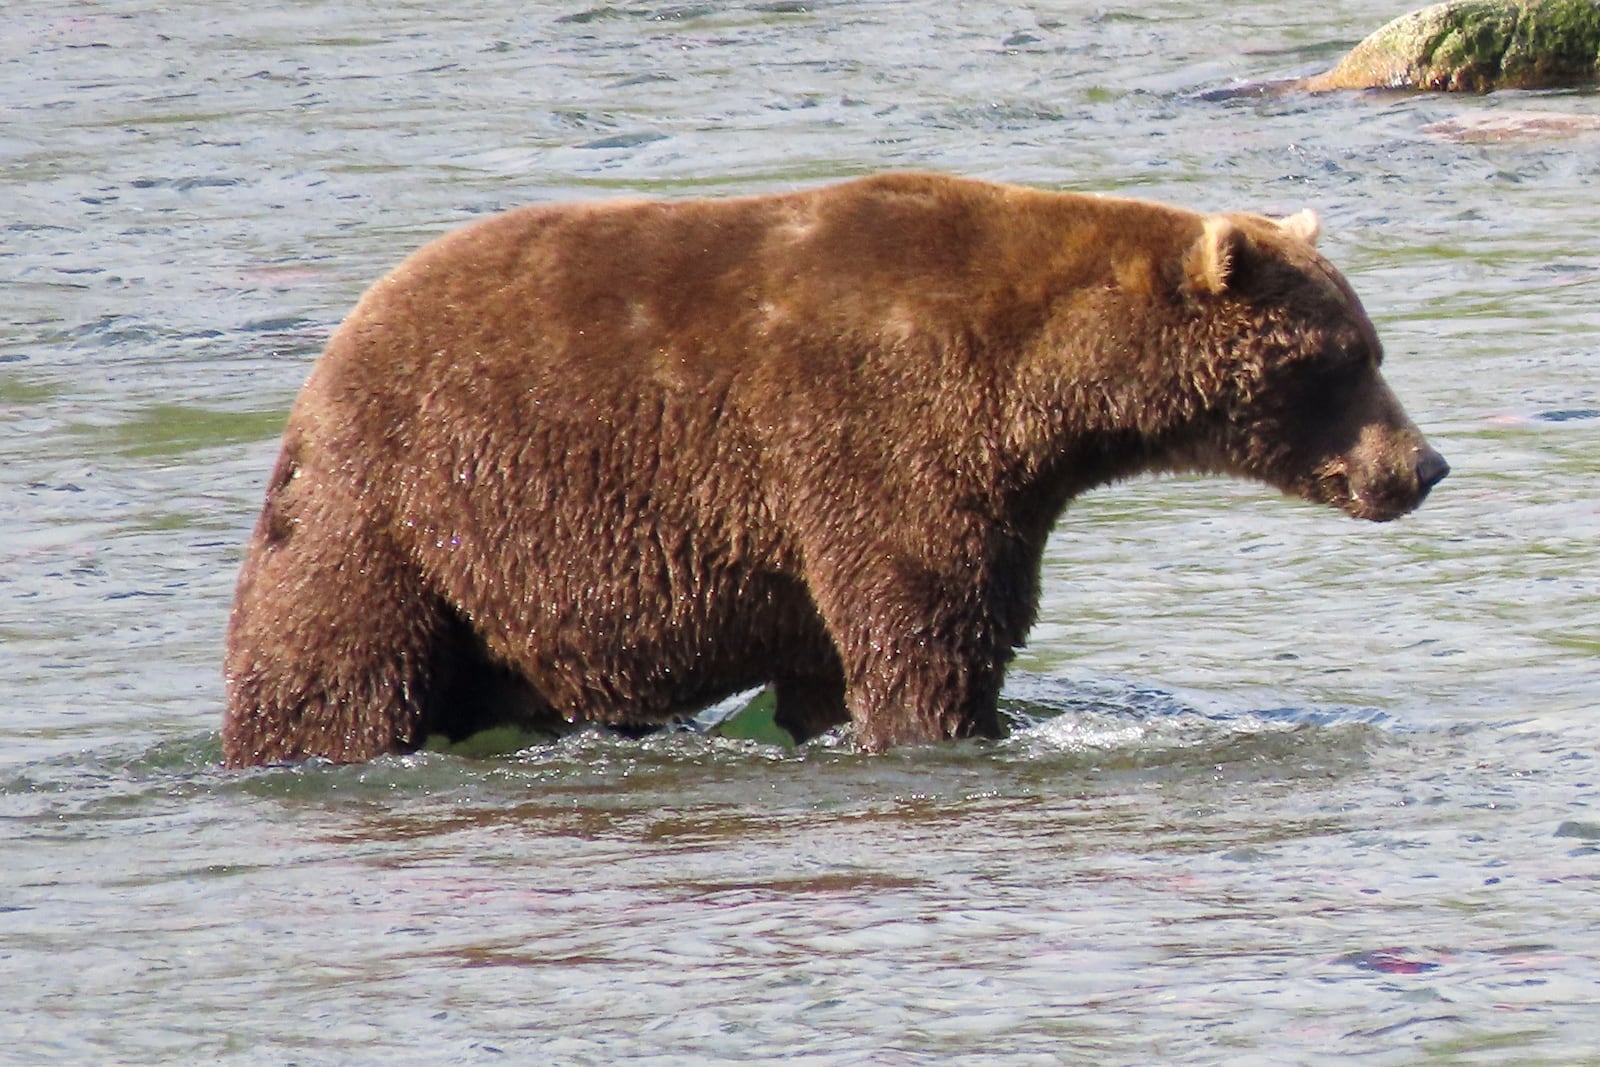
[222,174,1448,766]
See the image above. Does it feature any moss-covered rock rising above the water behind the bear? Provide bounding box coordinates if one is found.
[1302,0,1600,93]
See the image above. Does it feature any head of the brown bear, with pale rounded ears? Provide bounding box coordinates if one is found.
[1179,211,1450,522]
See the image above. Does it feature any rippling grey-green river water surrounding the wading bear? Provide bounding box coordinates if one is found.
[0,0,1600,1064]
